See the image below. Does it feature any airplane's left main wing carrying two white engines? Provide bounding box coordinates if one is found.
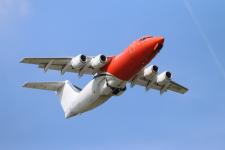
[21,55,113,76]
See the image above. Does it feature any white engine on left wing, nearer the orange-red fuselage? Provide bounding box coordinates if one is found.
[91,54,107,69]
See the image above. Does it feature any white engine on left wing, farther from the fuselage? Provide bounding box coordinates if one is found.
[71,54,87,69]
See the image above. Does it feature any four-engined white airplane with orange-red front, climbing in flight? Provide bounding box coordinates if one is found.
[21,35,188,118]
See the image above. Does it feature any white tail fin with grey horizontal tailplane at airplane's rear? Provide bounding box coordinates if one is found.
[23,80,81,118]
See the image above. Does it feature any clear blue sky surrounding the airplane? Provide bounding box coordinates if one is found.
[0,0,225,150]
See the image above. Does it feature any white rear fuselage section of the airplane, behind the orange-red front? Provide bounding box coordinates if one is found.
[65,74,126,118]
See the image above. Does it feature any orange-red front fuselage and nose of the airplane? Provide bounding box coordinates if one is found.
[103,37,164,81]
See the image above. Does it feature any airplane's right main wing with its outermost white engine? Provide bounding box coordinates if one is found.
[130,66,188,94]
